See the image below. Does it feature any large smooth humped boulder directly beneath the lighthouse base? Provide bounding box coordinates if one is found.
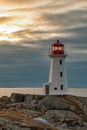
[39,96,77,112]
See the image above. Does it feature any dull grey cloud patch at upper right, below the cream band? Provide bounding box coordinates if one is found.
[44,10,87,29]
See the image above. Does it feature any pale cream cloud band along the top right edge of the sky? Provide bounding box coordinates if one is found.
[36,0,87,14]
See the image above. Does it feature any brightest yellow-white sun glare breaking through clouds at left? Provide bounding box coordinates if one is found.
[0,12,38,41]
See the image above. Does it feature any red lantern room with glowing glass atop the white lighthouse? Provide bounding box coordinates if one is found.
[52,40,64,55]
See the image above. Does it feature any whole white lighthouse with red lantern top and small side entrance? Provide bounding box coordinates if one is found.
[43,40,68,95]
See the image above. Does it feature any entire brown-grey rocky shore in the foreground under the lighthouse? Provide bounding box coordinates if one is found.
[0,93,87,130]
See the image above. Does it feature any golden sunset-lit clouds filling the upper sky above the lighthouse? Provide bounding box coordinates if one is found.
[0,0,87,47]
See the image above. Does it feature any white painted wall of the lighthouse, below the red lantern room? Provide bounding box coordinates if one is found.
[44,55,68,95]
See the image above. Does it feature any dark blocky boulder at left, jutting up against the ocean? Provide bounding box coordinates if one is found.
[10,93,24,102]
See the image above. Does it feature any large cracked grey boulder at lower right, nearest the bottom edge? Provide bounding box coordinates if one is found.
[43,110,83,127]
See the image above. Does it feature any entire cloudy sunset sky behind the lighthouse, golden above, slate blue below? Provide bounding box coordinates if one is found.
[0,0,87,88]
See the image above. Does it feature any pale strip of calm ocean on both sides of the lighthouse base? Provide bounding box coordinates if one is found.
[0,88,87,97]
